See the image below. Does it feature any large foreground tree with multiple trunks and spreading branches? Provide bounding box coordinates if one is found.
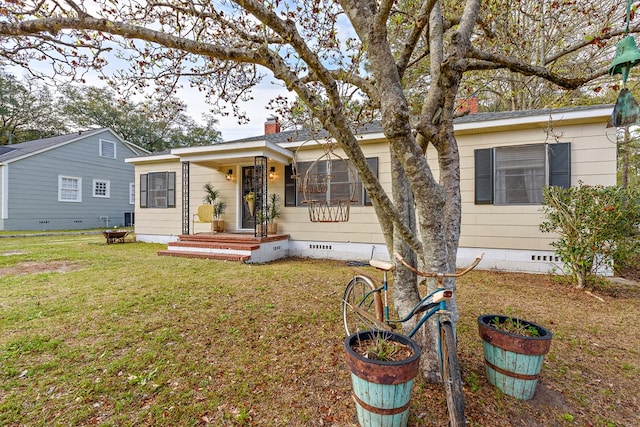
[0,0,638,378]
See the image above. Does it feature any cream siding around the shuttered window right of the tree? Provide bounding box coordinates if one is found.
[438,122,616,250]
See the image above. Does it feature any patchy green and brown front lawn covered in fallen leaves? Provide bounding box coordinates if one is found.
[0,235,640,427]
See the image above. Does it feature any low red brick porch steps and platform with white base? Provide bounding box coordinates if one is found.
[158,233,289,263]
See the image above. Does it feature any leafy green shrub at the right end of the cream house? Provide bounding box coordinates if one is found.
[540,182,640,288]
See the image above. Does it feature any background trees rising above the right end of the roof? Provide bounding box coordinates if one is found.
[460,0,637,111]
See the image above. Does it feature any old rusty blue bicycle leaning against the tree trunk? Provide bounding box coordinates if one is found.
[342,254,483,427]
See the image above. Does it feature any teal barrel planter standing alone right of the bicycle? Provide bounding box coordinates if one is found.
[478,314,552,400]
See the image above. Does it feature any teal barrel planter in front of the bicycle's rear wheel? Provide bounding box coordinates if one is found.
[344,331,420,427]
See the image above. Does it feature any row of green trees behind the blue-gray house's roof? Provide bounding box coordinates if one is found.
[0,73,221,152]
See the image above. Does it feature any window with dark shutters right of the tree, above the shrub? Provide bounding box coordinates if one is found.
[474,143,571,205]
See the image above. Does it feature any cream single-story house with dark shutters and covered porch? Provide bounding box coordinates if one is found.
[127,105,617,272]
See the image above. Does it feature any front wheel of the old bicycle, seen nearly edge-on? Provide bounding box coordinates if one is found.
[440,320,465,427]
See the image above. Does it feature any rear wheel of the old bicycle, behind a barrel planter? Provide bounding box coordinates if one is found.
[342,276,384,336]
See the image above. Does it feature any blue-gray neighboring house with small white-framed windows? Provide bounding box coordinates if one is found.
[0,128,149,230]
